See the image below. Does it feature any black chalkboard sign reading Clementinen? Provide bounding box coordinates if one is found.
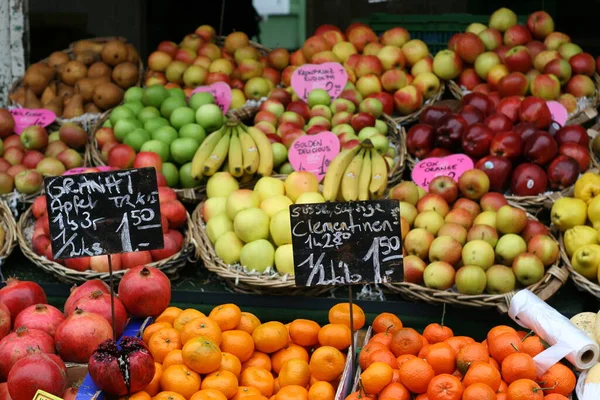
[290,200,404,286]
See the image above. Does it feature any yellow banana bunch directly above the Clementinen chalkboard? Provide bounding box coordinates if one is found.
[323,139,388,201]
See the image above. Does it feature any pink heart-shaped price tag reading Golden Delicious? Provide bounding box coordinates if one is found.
[288,131,340,182]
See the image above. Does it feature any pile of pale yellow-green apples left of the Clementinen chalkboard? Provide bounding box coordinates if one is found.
[200,171,325,275]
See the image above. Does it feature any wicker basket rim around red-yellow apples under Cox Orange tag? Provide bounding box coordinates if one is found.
[384,203,569,313]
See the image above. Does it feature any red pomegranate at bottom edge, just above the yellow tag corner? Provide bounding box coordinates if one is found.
[6,353,67,400]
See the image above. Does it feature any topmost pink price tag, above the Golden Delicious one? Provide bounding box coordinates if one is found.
[292,62,348,101]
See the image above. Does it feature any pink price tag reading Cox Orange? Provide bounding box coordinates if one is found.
[412,154,473,191]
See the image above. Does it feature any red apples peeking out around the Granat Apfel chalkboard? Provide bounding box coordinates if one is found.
[31,184,187,273]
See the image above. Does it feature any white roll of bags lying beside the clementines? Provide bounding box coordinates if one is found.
[508,289,600,376]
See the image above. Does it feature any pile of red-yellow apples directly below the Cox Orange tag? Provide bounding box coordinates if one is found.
[389,169,559,295]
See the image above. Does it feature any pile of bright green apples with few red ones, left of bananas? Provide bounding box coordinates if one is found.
[94,85,229,188]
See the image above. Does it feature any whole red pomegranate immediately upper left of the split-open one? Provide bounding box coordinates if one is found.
[54,309,112,363]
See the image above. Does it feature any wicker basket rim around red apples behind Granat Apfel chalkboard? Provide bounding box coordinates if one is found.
[17,207,195,284]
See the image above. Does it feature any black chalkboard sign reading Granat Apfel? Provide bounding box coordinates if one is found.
[44,168,164,259]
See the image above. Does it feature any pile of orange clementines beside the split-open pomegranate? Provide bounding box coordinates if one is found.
[119,303,365,400]
